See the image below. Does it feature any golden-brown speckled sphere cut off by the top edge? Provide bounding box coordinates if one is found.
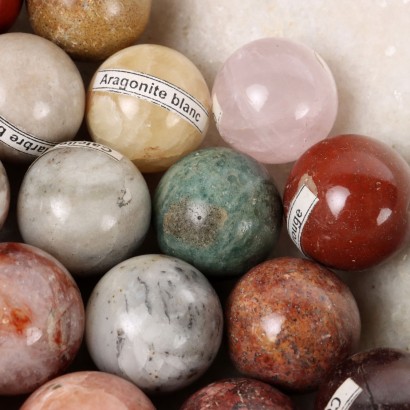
[26,0,151,61]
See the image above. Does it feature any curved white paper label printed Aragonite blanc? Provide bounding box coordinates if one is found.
[93,69,209,134]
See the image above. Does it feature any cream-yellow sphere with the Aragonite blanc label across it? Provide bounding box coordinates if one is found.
[86,44,211,172]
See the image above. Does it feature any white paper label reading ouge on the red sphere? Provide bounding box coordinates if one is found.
[286,184,319,253]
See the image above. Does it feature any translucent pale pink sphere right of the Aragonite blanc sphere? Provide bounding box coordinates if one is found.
[212,38,338,164]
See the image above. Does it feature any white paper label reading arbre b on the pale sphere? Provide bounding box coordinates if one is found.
[0,115,57,157]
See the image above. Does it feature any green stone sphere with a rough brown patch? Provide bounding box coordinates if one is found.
[153,147,282,276]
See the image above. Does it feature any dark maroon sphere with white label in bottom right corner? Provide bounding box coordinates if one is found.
[315,347,410,410]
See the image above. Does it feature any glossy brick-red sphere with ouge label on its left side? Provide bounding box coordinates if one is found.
[283,134,410,270]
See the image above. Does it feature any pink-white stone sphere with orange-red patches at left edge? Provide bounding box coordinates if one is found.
[0,242,85,396]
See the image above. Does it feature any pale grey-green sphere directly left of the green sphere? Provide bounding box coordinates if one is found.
[17,141,151,275]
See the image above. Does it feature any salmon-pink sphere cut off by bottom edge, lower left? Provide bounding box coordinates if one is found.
[20,371,155,410]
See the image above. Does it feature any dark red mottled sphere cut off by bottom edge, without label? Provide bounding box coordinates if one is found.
[181,377,295,410]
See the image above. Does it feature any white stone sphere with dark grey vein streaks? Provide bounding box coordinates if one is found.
[86,255,223,392]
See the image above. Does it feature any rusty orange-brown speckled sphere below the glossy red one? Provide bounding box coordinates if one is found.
[226,257,361,392]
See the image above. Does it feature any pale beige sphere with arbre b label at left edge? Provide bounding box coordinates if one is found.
[0,33,85,163]
